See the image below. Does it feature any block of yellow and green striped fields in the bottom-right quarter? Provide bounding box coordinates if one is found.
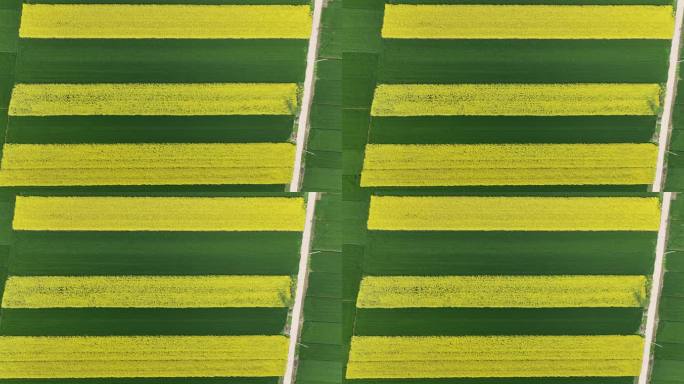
[345,193,660,384]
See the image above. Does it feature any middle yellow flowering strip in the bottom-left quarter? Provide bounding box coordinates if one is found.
[2,275,291,308]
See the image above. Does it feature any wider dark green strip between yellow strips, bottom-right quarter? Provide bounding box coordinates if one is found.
[366,231,656,276]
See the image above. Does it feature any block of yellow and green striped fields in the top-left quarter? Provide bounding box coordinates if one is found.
[0,0,312,191]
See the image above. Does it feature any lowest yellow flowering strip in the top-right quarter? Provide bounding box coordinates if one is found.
[361,143,658,187]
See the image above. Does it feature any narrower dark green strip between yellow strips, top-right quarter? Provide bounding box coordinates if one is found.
[366,116,656,144]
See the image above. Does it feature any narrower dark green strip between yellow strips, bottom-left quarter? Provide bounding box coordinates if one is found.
[0,308,288,336]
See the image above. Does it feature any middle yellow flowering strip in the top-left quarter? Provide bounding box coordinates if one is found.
[9,83,297,116]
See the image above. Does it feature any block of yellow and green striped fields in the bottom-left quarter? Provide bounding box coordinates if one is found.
[0,193,305,383]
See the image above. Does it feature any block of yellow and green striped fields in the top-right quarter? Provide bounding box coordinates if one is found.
[352,0,674,191]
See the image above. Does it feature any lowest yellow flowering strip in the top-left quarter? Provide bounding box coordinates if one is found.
[0,143,295,186]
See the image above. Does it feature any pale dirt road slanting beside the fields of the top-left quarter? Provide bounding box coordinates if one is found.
[290,0,323,192]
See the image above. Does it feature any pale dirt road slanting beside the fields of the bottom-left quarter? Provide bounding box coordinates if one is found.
[283,192,319,384]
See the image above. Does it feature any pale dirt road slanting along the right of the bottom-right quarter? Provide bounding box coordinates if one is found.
[638,192,672,384]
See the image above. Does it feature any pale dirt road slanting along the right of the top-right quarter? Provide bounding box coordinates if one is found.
[651,0,684,192]
